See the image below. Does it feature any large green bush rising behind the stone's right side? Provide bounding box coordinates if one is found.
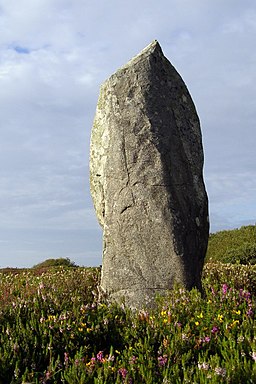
[206,225,256,265]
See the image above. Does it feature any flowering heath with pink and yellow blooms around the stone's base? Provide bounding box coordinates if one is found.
[0,263,256,384]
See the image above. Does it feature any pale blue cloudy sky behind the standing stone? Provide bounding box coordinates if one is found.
[0,0,256,268]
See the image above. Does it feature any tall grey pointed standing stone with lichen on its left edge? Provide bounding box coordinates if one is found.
[90,41,209,308]
